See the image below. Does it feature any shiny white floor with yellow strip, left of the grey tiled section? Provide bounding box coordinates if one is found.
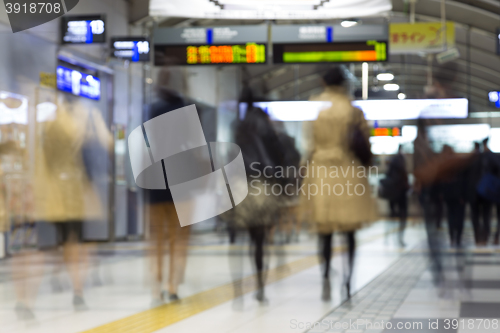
[0,219,424,333]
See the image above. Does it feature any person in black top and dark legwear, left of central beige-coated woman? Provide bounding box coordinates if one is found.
[230,108,284,302]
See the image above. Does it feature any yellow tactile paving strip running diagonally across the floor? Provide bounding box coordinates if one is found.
[81,229,397,333]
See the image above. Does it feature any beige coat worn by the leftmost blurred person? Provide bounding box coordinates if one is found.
[33,106,112,222]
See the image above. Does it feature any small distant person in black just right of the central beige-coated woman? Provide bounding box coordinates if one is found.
[381,146,410,247]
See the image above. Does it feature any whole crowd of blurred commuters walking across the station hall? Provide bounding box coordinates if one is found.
[4,67,500,319]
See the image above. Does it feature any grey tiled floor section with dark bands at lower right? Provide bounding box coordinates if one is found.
[308,223,500,333]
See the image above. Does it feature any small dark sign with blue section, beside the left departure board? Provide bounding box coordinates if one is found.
[111,37,149,62]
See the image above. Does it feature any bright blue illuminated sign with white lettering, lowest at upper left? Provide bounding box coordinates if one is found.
[56,66,101,100]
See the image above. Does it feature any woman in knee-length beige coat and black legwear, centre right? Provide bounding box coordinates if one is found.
[302,67,377,300]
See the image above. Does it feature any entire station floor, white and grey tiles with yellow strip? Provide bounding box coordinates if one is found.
[0,223,500,333]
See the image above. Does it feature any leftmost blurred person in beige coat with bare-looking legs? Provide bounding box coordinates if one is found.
[16,103,112,319]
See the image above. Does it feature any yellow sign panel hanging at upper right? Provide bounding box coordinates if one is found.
[389,22,455,54]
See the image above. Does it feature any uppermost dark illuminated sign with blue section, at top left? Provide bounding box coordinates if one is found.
[61,15,106,44]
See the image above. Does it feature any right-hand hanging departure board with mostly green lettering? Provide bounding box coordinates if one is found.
[272,25,389,64]
